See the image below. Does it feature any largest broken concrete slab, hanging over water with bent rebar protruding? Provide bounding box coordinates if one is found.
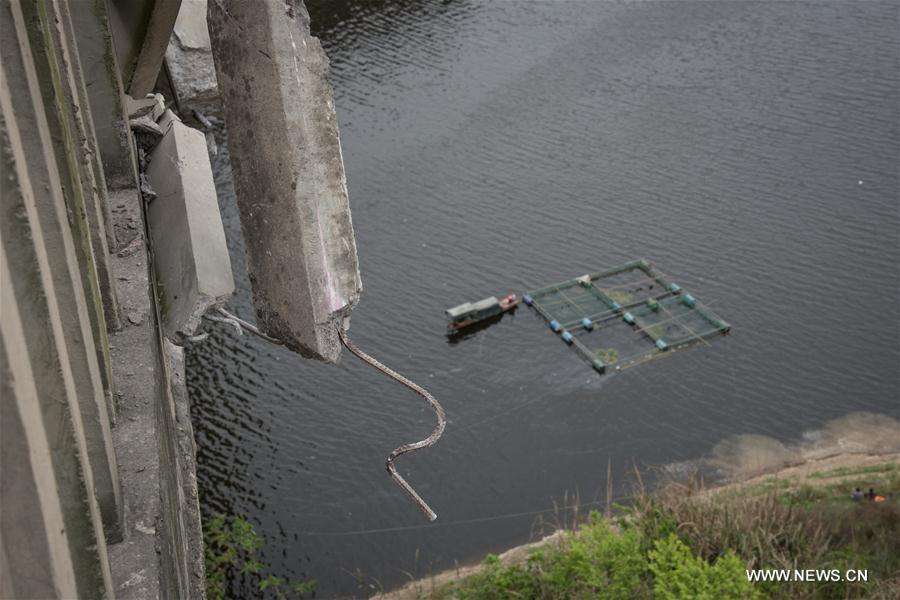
[208,0,362,362]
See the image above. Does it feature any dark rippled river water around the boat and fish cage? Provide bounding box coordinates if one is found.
[188,0,900,597]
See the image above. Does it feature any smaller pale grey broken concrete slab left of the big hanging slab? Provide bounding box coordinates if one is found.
[144,111,234,337]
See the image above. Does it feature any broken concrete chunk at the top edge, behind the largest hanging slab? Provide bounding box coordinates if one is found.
[166,0,219,114]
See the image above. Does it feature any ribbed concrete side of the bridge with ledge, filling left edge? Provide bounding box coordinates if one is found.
[0,0,204,598]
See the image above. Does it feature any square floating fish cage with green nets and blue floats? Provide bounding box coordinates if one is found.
[522,260,731,373]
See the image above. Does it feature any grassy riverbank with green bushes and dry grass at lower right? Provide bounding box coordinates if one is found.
[391,455,900,599]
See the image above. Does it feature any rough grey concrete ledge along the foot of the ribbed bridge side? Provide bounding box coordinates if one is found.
[109,188,205,599]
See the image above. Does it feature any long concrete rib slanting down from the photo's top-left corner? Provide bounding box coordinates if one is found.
[0,3,122,542]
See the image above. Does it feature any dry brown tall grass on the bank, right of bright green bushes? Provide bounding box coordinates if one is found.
[633,479,900,598]
